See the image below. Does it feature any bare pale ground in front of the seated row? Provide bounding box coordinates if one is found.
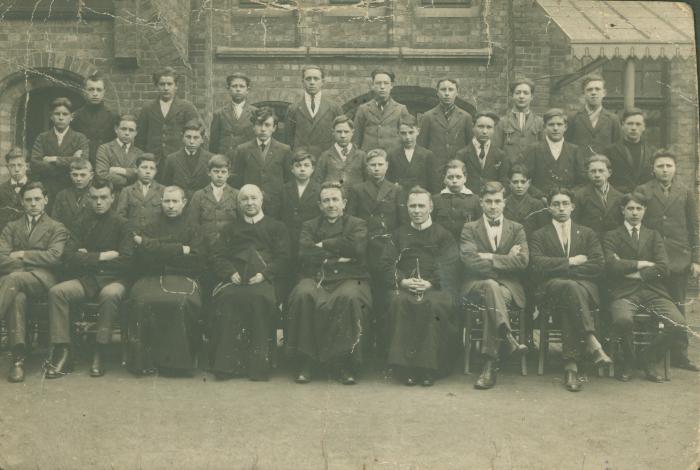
[0,312,700,470]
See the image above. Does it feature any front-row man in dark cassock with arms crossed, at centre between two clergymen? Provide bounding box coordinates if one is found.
[287,182,372,385]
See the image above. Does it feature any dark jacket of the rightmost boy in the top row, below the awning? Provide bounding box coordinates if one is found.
[565,108,622,157]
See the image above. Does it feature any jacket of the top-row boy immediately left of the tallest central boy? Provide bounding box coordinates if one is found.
[209,101,258,158]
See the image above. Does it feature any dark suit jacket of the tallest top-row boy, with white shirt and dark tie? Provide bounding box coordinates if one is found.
[286,93,343,158]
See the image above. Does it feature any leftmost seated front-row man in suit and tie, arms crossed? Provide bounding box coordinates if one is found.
[0,182,68,382]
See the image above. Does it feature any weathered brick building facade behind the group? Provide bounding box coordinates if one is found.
[0,0,698,186]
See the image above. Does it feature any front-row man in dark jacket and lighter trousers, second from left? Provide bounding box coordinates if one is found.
[45,179,132,379]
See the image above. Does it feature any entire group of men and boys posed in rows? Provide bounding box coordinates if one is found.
[0,66,700,391]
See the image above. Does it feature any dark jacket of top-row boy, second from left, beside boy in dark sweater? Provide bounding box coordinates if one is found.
[134,97,199,163]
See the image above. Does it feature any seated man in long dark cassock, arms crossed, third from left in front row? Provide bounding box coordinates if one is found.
[128,186,204,374]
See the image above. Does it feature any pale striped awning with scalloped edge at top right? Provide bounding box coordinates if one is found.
[537,0,695,59]
